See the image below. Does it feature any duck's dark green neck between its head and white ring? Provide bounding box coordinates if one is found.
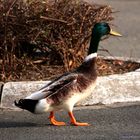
[88,35,101,55]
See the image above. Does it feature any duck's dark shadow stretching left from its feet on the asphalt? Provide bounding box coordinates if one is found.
[0,122,51,128]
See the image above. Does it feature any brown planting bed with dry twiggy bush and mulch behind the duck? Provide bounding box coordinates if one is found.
[0,0,140,82]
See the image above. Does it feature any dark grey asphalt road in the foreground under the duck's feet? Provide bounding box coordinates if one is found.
[0,105,140,140]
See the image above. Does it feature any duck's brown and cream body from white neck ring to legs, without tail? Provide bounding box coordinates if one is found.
[23,55,97,113]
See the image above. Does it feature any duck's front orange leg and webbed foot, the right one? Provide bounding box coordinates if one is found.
[68,112,89,126]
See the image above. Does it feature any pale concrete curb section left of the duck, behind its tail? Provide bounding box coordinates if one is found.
[0,81,48,109]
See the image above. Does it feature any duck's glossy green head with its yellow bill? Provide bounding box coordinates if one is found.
[92,22,121,37]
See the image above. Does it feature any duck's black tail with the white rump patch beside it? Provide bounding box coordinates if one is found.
[14,99,48,113]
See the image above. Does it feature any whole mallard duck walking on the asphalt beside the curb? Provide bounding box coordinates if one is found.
[15,22,121,126]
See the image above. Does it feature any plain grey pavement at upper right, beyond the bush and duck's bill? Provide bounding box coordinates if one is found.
[85,0,140,58]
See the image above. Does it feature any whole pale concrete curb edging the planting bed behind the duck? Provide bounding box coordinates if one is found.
[0,57,140,109]
